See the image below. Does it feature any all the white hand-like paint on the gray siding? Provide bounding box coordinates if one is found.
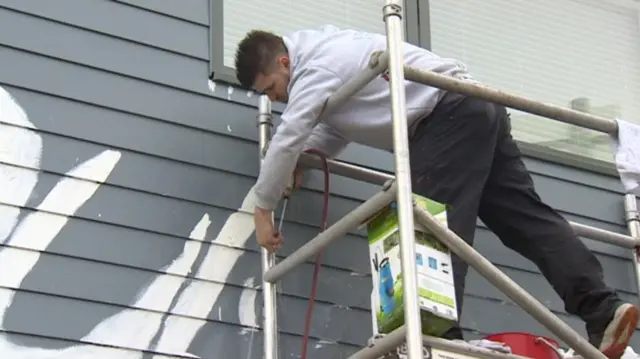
[0,88,257,359]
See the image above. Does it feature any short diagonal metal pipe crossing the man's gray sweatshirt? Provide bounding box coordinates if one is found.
[322,51,389,116]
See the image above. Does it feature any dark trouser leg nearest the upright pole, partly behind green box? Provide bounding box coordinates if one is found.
[410,95,500,339]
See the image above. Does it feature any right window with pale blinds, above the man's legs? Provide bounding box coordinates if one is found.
[429,0,640,163]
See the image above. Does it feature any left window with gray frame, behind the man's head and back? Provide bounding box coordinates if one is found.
[209,0,419,84]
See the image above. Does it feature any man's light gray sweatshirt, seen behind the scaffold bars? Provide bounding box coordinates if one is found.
[255,26,473,210]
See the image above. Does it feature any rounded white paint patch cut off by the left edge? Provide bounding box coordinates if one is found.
[0,91,42,244]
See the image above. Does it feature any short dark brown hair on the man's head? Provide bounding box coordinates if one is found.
[236,30,287,88]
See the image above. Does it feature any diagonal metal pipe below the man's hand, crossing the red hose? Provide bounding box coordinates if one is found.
[262,182,396,283]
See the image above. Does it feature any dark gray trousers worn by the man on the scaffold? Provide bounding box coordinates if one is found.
[410,93,620,339]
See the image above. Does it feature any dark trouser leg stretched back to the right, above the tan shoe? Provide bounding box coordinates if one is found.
[479,110,619,333]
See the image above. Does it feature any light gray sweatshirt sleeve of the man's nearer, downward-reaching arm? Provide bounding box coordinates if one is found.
[255,67,342,210]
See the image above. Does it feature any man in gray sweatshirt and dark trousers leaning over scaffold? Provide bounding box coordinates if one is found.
[236,26,638,359]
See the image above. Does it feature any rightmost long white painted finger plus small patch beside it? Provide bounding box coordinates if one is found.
[152,188,256,352]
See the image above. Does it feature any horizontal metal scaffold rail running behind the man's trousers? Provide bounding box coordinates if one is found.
[300,154,640,248]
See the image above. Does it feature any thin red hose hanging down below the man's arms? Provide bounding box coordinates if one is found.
[300,149,329,359]
